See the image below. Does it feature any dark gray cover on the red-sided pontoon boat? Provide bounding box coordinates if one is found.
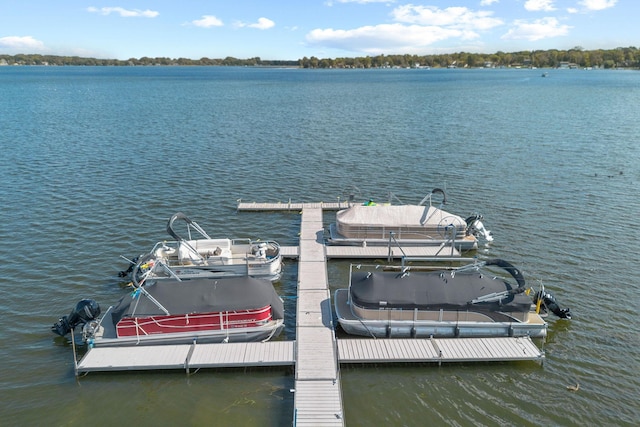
[112,277,284,325]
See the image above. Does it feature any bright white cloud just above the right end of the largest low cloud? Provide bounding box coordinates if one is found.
[391,4,503,30]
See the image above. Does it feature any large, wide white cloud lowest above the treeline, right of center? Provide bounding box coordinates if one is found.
[306,24,478,55]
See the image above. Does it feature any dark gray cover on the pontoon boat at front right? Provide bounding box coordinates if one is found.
[350,270,532,312]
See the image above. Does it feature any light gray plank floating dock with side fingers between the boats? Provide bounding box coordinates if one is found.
[75,201,544,426]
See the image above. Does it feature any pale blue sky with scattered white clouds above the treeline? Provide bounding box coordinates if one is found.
[0,0,640,60]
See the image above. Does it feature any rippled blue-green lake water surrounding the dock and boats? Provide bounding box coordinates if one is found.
[0,67,640,426]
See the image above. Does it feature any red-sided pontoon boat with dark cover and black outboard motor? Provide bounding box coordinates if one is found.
[52,277,284,347]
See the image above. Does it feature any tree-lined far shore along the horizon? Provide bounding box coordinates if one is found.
[0,47,640,69]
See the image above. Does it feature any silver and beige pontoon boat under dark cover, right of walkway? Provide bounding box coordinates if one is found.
[334,260,570,337]
